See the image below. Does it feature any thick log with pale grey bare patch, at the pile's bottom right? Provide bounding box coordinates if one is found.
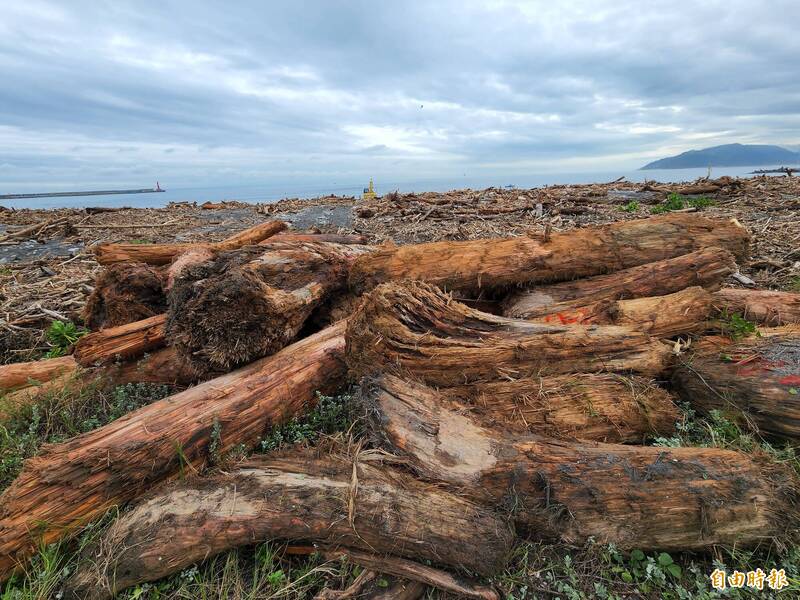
[363,378,798,550]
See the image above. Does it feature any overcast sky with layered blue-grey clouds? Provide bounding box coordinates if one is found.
[0,0,800,189]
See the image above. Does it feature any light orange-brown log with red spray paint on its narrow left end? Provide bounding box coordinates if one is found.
[530,287,712,338]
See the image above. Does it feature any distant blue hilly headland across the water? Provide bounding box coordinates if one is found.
[640,144,800,170]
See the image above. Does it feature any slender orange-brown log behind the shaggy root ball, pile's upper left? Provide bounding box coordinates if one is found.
[93,221,286,265]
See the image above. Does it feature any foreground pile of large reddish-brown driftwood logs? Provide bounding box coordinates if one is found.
[0,214,800,598]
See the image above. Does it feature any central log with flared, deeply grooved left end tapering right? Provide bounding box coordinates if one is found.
[347,282,671,387]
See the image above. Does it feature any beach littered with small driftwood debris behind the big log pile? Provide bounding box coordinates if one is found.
[0,177,800,362]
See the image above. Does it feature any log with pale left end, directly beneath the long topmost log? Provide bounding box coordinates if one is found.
[503,248,736,319]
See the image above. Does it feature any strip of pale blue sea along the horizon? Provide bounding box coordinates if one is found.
[0,166,788,208]
